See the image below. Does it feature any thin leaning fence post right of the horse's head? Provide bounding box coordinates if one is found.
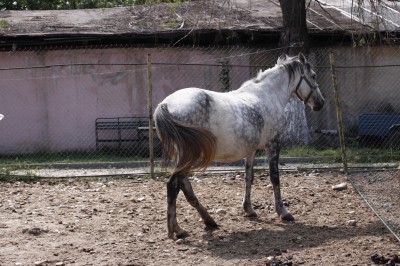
[329,49,347,173]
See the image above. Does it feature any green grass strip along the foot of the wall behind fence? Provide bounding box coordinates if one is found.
[0,146,400,172]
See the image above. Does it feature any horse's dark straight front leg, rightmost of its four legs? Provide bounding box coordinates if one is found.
[267,140,294,221]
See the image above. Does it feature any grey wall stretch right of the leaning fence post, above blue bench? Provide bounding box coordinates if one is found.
[336,46,400,130]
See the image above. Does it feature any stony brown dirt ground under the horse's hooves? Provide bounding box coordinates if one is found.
[0,170,400,266]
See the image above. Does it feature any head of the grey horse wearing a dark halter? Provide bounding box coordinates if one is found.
[278,53,325,111]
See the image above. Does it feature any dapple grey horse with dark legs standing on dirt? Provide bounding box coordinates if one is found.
[153,53,325,239]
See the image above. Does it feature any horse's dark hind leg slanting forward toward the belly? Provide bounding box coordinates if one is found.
[181,176,218,230]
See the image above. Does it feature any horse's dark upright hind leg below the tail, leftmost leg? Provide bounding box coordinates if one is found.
[167,173,188,238]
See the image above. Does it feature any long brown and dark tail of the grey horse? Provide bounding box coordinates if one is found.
[154,104,217,173]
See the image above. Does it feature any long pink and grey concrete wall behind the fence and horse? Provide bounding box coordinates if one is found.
[0,46,400,154]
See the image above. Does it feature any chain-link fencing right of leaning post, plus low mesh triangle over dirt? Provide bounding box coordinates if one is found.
[335,46,400,241]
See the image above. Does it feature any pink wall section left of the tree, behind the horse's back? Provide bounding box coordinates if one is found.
[0,48,249,154]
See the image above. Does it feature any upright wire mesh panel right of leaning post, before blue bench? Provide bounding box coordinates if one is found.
[336,46,400,163]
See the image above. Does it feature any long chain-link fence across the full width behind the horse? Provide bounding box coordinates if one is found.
[0,47,400,175]
